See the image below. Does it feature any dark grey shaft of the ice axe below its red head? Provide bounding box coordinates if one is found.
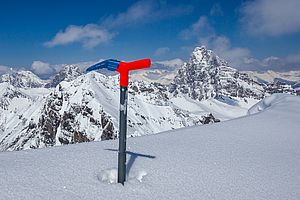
[118,86,128,185]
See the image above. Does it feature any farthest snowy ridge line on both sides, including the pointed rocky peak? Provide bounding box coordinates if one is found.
[0,46,300,97]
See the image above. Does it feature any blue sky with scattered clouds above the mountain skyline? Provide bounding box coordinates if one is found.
[0,0,300,74]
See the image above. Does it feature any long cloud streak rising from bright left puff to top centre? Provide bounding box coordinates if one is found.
[44,0,192,48]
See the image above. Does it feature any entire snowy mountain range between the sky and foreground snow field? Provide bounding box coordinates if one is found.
[0,47,297,151]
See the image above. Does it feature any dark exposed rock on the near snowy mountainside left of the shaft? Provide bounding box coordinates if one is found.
[7,85,116,150]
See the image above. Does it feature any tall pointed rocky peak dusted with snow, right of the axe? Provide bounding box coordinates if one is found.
[169,46,264,101]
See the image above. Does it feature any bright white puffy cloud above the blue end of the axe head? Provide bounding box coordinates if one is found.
[45,24,115,48]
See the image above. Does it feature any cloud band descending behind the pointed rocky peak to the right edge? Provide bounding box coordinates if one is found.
[180,16,300,71]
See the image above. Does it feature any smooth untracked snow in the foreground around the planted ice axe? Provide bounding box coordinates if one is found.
[0,95,300,200]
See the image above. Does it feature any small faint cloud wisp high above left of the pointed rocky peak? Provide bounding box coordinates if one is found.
[179,16,213,39]
